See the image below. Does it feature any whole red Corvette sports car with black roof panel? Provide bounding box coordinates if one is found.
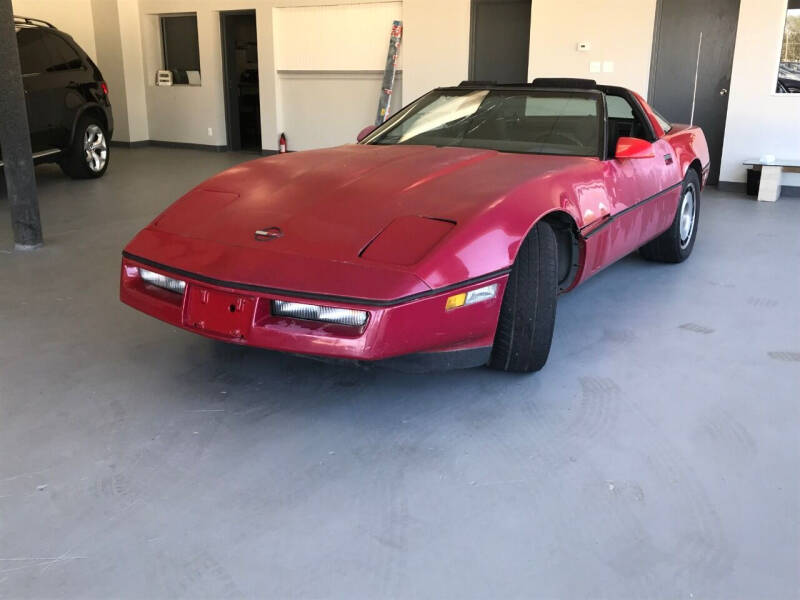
[120,79,709,372]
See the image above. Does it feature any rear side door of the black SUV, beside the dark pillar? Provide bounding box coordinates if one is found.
[17,27,53,152]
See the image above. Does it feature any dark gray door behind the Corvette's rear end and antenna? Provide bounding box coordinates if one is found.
[649,0,740,184]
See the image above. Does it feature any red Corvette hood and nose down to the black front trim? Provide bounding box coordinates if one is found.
[126,145,592,297]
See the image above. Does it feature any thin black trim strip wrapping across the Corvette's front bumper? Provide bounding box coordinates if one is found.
[122,251,511,306]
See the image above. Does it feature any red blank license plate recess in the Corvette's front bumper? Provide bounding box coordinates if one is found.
[183,285,256,340]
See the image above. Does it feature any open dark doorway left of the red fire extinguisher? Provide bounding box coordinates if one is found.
[220,10,261,152]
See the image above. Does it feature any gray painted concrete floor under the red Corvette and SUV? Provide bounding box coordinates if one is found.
[0,148,800,600]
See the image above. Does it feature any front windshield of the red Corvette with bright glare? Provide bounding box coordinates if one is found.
[363,89,601,156]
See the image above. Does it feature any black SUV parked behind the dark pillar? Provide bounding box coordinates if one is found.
[0,16,114,178]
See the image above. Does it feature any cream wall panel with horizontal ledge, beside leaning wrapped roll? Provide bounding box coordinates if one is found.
[273,2,402,150]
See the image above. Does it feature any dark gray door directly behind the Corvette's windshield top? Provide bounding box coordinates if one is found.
[469,0,531,83]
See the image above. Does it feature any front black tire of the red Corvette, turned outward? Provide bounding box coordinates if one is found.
[489,222,558,373]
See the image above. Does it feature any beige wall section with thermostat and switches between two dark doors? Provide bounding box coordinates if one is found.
[528,0,656,96]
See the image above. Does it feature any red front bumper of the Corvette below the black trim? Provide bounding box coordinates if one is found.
[120,257,508,371]
